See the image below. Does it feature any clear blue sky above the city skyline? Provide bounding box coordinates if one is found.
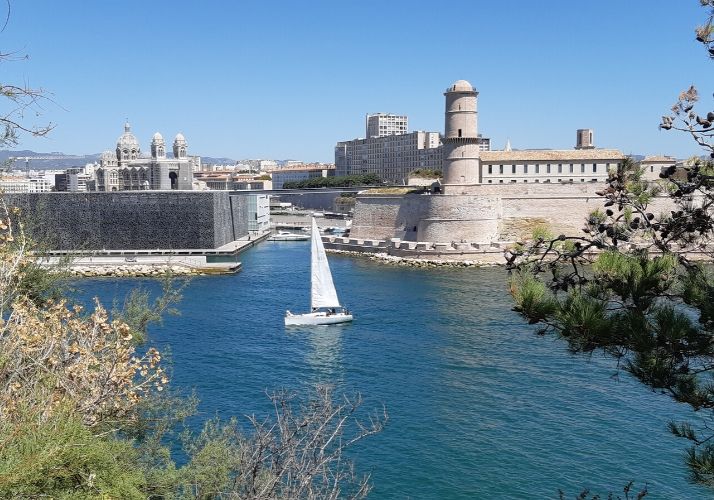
[0,0,714,162]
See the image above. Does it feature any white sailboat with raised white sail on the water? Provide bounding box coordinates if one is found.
[285,217,352,326]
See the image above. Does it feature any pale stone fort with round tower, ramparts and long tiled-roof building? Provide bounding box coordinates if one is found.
[348,80,672,250]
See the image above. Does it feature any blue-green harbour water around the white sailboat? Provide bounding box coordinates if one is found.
[80,242,709,499]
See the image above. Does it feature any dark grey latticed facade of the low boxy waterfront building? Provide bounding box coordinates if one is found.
[4,191,239,250]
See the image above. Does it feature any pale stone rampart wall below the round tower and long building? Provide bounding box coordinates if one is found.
[350,183,672,244]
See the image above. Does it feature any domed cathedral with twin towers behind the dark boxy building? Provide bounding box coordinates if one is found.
[94,122,201,191]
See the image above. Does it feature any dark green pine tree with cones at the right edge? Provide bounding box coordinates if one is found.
[507,0,714,487]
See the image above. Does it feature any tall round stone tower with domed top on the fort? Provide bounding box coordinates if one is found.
[443,80,481,189]
